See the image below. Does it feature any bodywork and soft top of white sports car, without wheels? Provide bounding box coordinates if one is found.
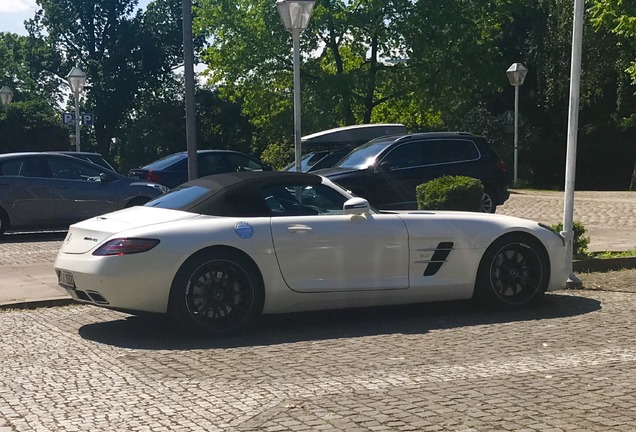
[55,172,567,313]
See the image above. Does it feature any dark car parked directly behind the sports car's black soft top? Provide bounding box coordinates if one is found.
[128,150,272,188]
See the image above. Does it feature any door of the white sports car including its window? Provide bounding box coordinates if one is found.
[264,185,409,292]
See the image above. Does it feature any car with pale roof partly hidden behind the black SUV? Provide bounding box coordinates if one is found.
[284,123,406,172]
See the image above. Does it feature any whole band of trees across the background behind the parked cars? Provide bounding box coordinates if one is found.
[0,0,636,189]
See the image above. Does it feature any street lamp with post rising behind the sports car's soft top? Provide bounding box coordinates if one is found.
[276,0,315,172]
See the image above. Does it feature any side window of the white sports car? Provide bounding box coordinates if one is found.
[261,185,347,216]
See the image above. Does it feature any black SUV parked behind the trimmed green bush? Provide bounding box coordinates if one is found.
[314,132,510,213]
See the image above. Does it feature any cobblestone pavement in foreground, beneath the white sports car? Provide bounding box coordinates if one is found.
[0,278,636,432]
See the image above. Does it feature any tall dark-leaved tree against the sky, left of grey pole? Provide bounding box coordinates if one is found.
[27,0,189,155]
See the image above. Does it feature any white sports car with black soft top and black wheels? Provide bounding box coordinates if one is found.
[55,172,567,334]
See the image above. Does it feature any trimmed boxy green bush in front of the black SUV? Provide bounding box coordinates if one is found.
[415,176,484,211]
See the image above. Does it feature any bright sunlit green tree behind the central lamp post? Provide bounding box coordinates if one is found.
[195,0,418,142]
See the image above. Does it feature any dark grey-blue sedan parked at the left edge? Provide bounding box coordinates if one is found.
[0,152,168,234]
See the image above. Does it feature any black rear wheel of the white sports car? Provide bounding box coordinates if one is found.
[169,250,264,336]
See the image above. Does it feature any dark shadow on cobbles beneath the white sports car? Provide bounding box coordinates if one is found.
[79,294,601,350]
